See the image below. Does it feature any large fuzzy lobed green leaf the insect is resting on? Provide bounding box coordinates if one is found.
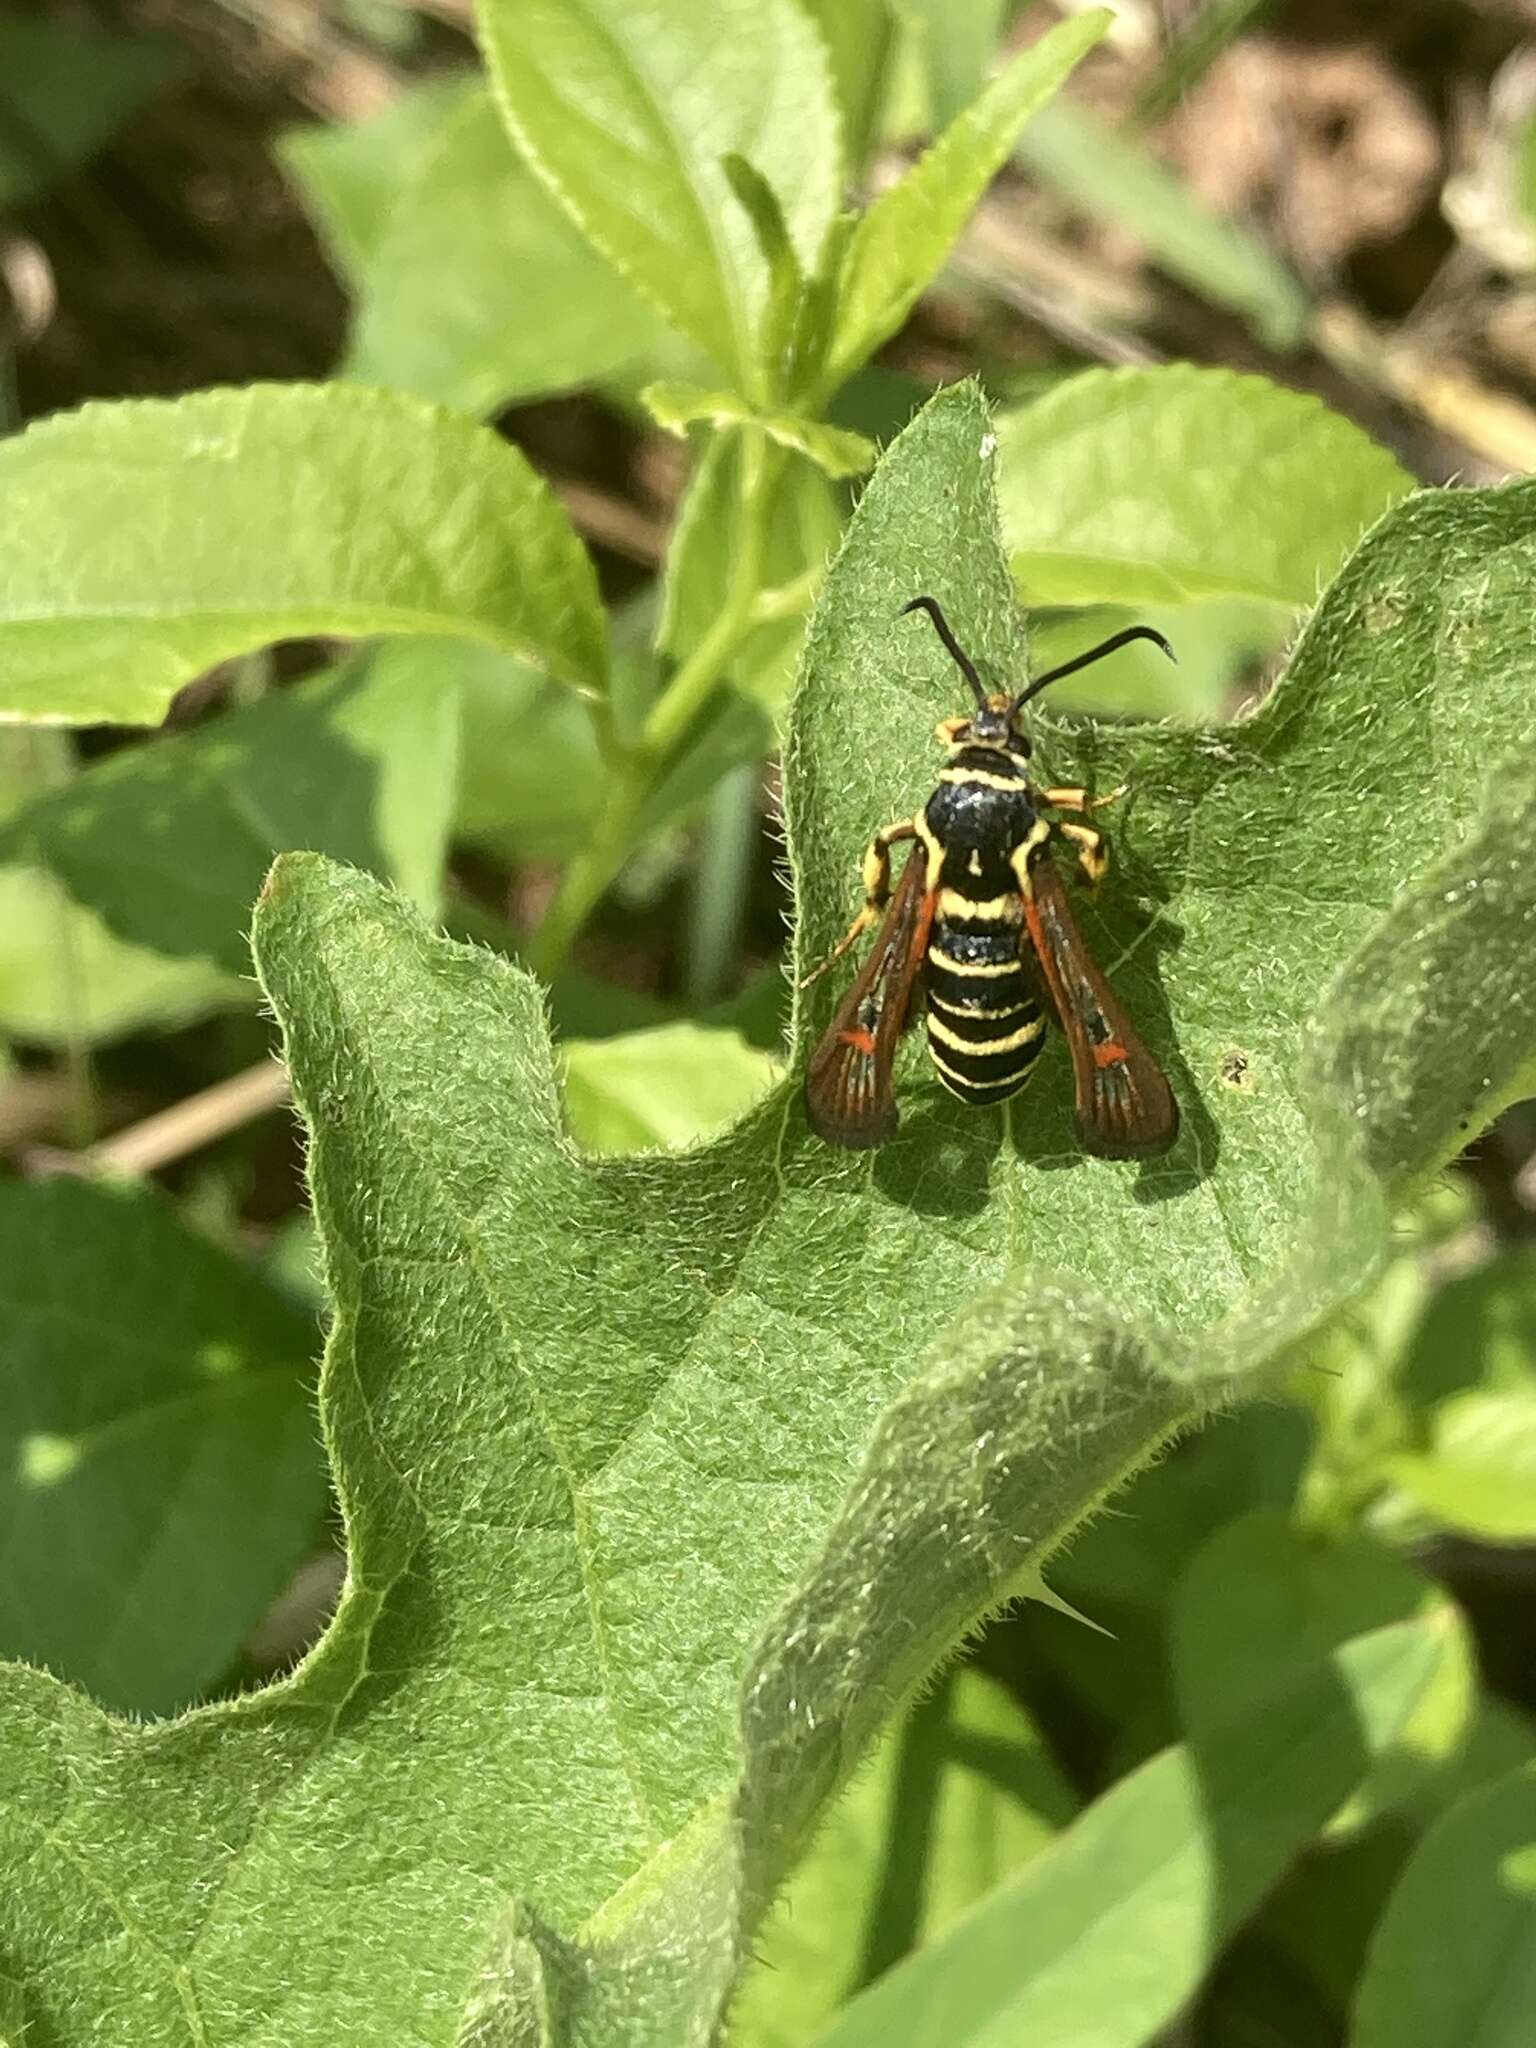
[0,387,1536,2048]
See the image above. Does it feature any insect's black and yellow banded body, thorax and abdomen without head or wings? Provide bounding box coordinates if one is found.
[913,741,1049,1104]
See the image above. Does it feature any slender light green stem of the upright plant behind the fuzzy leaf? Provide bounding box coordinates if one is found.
[528,428,784,977]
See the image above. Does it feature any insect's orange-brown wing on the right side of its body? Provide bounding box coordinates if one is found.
[1024,854,1180,1159]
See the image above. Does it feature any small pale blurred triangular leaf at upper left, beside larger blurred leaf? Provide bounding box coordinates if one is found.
[274,72,473,282]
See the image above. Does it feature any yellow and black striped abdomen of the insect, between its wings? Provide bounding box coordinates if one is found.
[924,921,1044,1104]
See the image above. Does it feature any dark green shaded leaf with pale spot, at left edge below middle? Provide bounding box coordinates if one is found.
[0,1180,326,1714]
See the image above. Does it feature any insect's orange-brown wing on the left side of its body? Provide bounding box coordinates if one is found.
[805,846,934,1151]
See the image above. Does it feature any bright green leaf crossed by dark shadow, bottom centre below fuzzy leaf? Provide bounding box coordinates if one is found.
[727,1667,1075,2048]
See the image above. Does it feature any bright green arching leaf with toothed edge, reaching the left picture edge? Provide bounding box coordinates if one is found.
[0,385,606,725]
